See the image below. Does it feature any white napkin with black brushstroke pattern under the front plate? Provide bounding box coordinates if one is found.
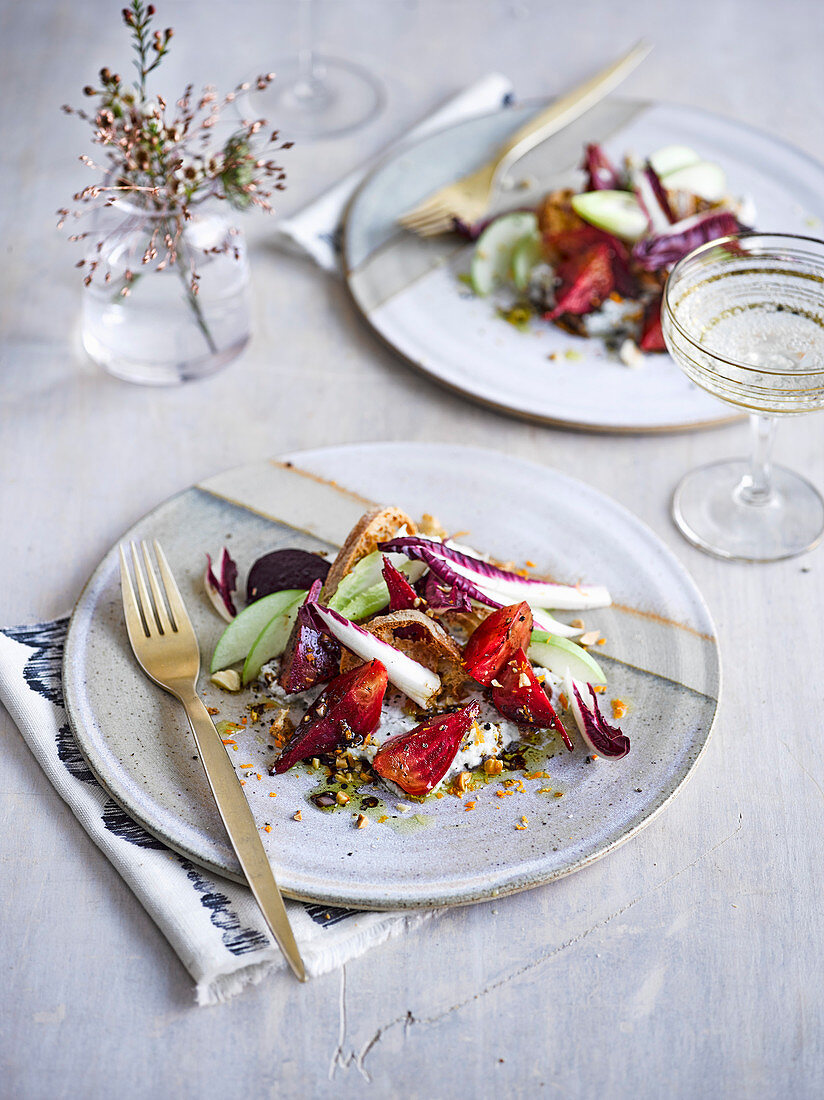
[0,618,437,1004]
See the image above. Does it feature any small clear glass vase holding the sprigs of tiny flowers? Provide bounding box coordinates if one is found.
[83,199,251,386]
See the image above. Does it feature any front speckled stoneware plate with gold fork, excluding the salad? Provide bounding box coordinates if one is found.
[65,443,719,909]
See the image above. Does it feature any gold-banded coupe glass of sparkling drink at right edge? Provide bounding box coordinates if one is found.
[661,233,824,561]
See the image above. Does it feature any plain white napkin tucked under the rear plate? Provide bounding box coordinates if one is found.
[274,73,513,274]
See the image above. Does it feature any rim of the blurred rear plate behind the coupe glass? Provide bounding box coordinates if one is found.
[340,96,824,436]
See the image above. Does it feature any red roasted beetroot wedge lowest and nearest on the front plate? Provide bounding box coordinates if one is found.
[372,703,481,799]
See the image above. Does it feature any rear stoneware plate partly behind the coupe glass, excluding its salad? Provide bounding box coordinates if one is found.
[343,98,824,431]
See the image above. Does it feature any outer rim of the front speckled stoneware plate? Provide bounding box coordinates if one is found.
[62,441,724,911]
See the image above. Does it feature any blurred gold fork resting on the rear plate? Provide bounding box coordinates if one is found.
[398,41,652,237]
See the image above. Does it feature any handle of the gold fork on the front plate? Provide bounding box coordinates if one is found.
[180,690,306,981]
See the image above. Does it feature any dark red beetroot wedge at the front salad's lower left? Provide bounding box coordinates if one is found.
[272,661,387,776]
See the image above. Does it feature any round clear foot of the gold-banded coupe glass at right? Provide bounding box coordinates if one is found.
[672,460,824,561]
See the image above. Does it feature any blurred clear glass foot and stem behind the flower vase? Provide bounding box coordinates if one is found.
[249,0,384,141]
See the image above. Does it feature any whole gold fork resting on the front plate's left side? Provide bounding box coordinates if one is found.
[120,540,306,981]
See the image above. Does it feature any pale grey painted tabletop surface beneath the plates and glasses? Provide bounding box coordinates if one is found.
[0,0,824,1100]
